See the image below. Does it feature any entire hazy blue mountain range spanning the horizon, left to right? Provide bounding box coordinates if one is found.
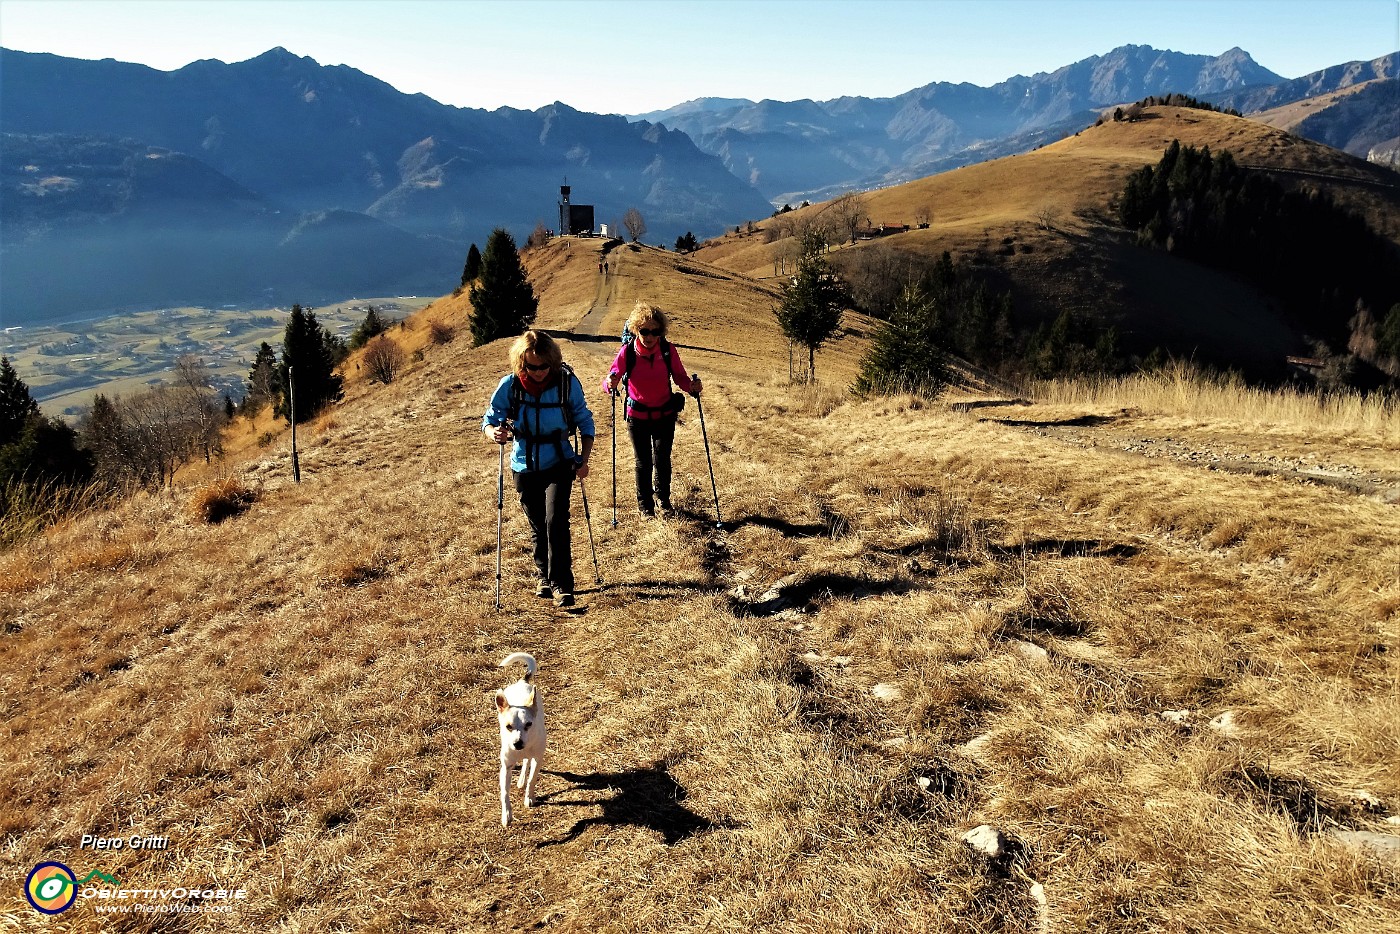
[0,46,1400,325]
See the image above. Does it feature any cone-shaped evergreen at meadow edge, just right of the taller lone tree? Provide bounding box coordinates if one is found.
[854,279,949,399]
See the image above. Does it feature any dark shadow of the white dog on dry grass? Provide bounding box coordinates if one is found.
[536,762,715,847]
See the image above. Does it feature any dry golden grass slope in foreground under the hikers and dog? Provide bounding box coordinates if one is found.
[0,224,1400,931]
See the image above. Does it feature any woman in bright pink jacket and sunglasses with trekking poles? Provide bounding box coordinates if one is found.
[603,301,700,518]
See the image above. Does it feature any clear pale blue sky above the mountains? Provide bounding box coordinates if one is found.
[0,0,1400,119]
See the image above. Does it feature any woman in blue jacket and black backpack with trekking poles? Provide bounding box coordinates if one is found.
[482,330,594,606]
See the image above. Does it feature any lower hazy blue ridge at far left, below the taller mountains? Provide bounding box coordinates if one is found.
[0,133,461,326]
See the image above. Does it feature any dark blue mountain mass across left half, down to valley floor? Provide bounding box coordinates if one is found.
[0,49,770,321]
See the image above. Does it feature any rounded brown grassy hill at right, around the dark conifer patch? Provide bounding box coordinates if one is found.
[699,108,1400,371]
